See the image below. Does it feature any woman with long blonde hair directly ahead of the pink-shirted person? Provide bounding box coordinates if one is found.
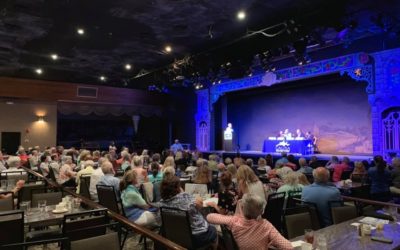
[236,165,266,202]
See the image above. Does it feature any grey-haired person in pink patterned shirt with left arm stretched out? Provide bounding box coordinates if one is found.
[207,193,293,250]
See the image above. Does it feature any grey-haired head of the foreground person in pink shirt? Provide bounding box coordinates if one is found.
[240,193,265,220]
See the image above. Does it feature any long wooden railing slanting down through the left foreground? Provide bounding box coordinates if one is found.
[22,167,185,250]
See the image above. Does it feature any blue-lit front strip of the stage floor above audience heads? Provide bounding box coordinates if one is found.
[203,150,373,162]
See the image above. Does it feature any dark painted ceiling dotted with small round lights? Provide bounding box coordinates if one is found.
[0,0,399,88]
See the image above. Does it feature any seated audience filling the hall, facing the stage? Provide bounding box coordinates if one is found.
[0,145,400,249]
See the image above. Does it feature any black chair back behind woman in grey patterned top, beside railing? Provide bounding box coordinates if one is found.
[160,207,211,249]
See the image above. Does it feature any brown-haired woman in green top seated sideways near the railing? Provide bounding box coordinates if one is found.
[120,170,158,228]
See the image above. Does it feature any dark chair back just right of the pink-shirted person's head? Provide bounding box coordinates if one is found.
[262,192,285,232]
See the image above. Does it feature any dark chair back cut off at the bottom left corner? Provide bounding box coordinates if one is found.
[0,210,24,249]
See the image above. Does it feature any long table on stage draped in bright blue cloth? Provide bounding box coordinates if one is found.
[263,138,314,155]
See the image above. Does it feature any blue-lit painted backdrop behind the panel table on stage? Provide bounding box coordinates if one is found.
[228,75,372,154]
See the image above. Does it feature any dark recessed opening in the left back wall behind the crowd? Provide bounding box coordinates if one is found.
[57,114,168,152]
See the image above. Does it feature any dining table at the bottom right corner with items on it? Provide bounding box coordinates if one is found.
[290,217,400,250]
